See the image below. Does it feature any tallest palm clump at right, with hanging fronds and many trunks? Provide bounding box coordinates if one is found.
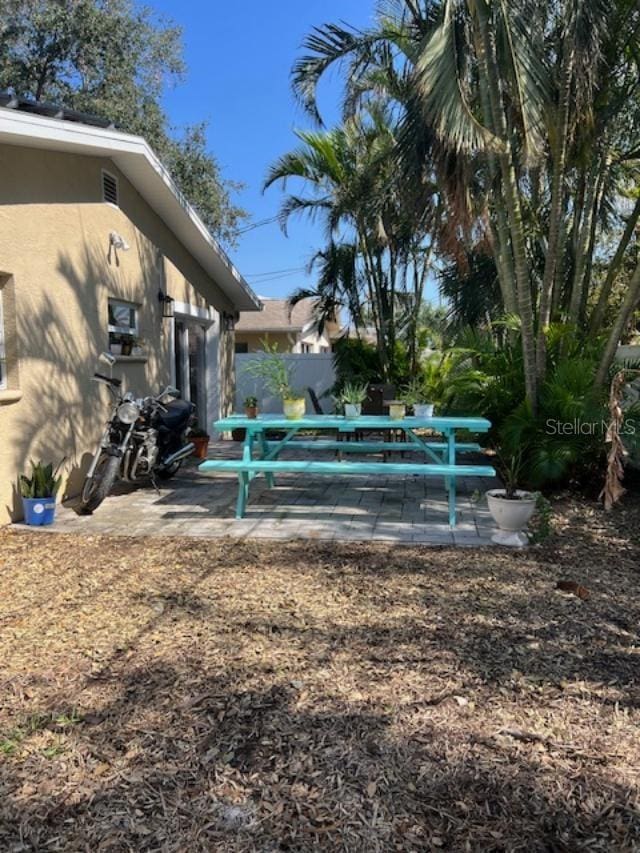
[293,0,640,411]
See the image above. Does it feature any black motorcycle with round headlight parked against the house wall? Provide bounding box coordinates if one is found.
[80,353,195,515]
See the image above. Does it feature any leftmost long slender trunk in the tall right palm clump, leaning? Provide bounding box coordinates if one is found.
[477,3,538,412]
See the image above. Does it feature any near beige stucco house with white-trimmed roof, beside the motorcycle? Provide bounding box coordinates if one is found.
[0,97,260,524]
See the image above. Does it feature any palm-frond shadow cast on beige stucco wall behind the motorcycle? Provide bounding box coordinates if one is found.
[8,240,168,520]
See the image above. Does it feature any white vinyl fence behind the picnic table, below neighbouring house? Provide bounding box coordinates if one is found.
[235,353,336,414]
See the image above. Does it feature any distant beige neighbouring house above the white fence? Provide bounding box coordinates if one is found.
[235,296,340,354]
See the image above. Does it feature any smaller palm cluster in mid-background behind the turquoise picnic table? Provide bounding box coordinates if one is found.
[265,107,431,377]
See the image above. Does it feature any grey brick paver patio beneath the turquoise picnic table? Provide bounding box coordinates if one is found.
[16,441,495,546]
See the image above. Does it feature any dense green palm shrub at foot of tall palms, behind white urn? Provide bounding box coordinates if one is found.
[442,321,608,489]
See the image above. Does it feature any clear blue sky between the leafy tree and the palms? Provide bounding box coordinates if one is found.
[150,0,374,296]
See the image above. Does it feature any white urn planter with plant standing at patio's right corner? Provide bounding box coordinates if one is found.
[487,450,538,548]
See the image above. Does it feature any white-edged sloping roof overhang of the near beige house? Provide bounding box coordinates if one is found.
[0,94,261,312]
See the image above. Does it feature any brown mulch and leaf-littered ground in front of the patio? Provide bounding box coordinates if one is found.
[0,497,640,853]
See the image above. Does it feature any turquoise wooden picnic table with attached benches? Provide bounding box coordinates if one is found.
[199,415,495,527]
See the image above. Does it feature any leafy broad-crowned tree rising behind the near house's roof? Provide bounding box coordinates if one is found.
[0,0,246,242]
